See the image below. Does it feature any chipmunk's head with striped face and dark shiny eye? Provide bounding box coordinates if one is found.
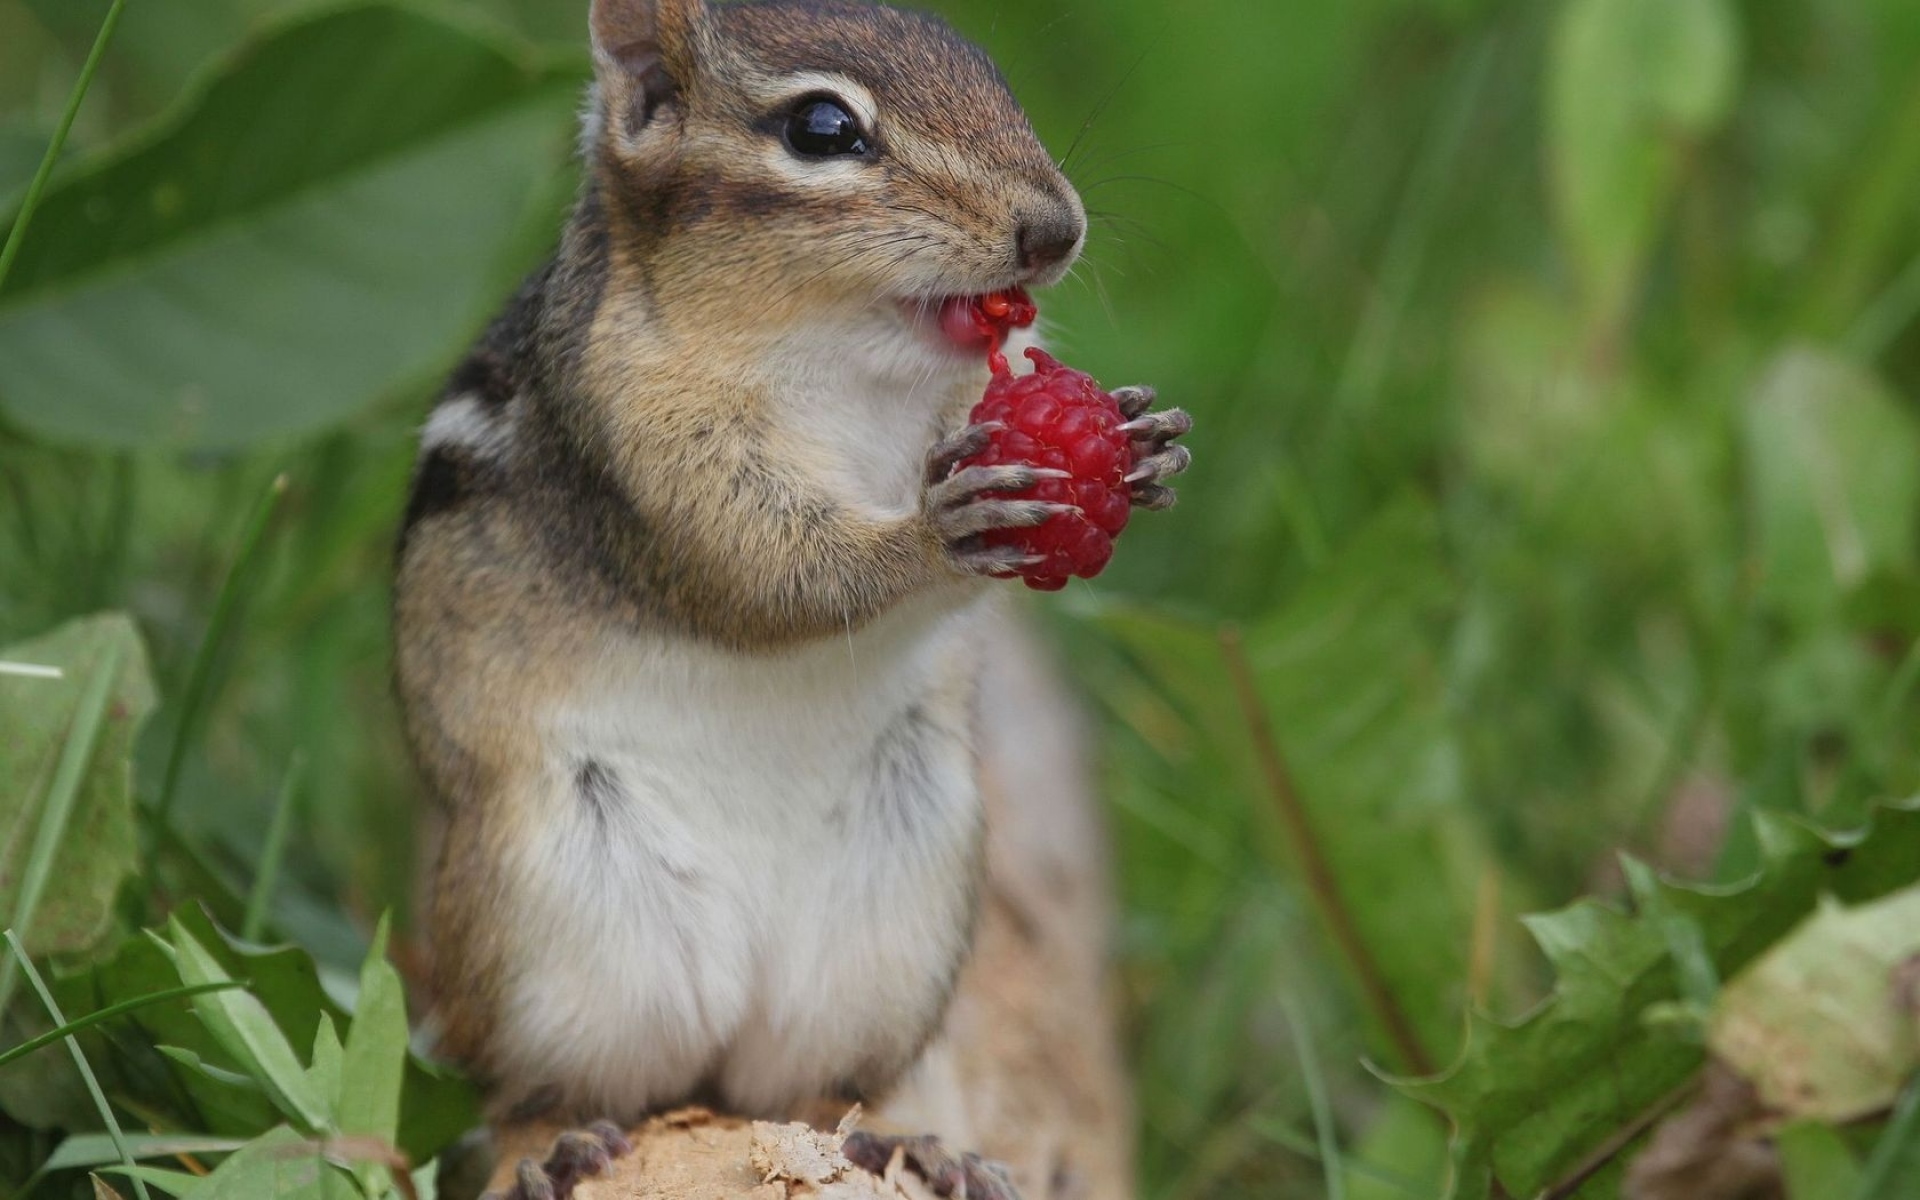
[588,0,1087,363]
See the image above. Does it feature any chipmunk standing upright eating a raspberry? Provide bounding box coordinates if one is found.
[396,0,1188,1200]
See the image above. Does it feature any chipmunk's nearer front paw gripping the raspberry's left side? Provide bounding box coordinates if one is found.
[924,424,1079,574]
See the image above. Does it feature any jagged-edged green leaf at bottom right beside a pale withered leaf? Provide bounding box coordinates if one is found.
[1398,803,1920,1196]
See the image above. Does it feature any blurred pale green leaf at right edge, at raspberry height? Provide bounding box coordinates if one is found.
[1743,348,1920,622]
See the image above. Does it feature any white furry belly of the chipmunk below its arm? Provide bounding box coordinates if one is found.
[501,595,981,1117]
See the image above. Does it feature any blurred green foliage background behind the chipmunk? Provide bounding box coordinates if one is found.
[0,0,1920,1200]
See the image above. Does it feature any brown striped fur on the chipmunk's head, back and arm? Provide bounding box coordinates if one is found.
[396,0,1083,1096]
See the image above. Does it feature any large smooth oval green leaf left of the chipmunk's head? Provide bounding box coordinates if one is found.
[0,4,578,447]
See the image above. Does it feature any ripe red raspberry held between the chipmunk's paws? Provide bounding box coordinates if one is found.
[960,349,1133,591]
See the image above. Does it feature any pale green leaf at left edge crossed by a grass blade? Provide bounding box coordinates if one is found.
[0,614,154,954]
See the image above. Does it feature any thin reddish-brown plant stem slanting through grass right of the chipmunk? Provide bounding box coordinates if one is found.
[1219,626,1438,1075]
